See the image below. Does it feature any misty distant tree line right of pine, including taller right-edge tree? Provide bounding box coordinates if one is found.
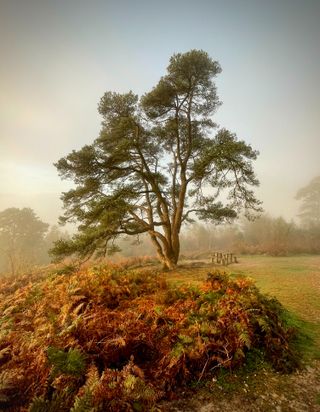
[181,176,320,256]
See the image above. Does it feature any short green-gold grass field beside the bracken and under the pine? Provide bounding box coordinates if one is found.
[168,256,320,358]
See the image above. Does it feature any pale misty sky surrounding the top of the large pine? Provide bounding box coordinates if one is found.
[0,0,320,224]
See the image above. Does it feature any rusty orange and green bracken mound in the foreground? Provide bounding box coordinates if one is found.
[0,265,300,412]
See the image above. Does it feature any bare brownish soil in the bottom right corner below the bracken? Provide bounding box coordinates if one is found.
[159,361,320,412]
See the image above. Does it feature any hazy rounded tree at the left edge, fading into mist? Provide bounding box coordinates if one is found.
[0,207,49,274]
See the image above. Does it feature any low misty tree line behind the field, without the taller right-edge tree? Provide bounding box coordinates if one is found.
[181,215,320,256]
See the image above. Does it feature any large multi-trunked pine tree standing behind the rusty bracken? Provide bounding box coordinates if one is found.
[52,50,260,269]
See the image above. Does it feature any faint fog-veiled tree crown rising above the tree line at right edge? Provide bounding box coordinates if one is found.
[296,176,320,228]
